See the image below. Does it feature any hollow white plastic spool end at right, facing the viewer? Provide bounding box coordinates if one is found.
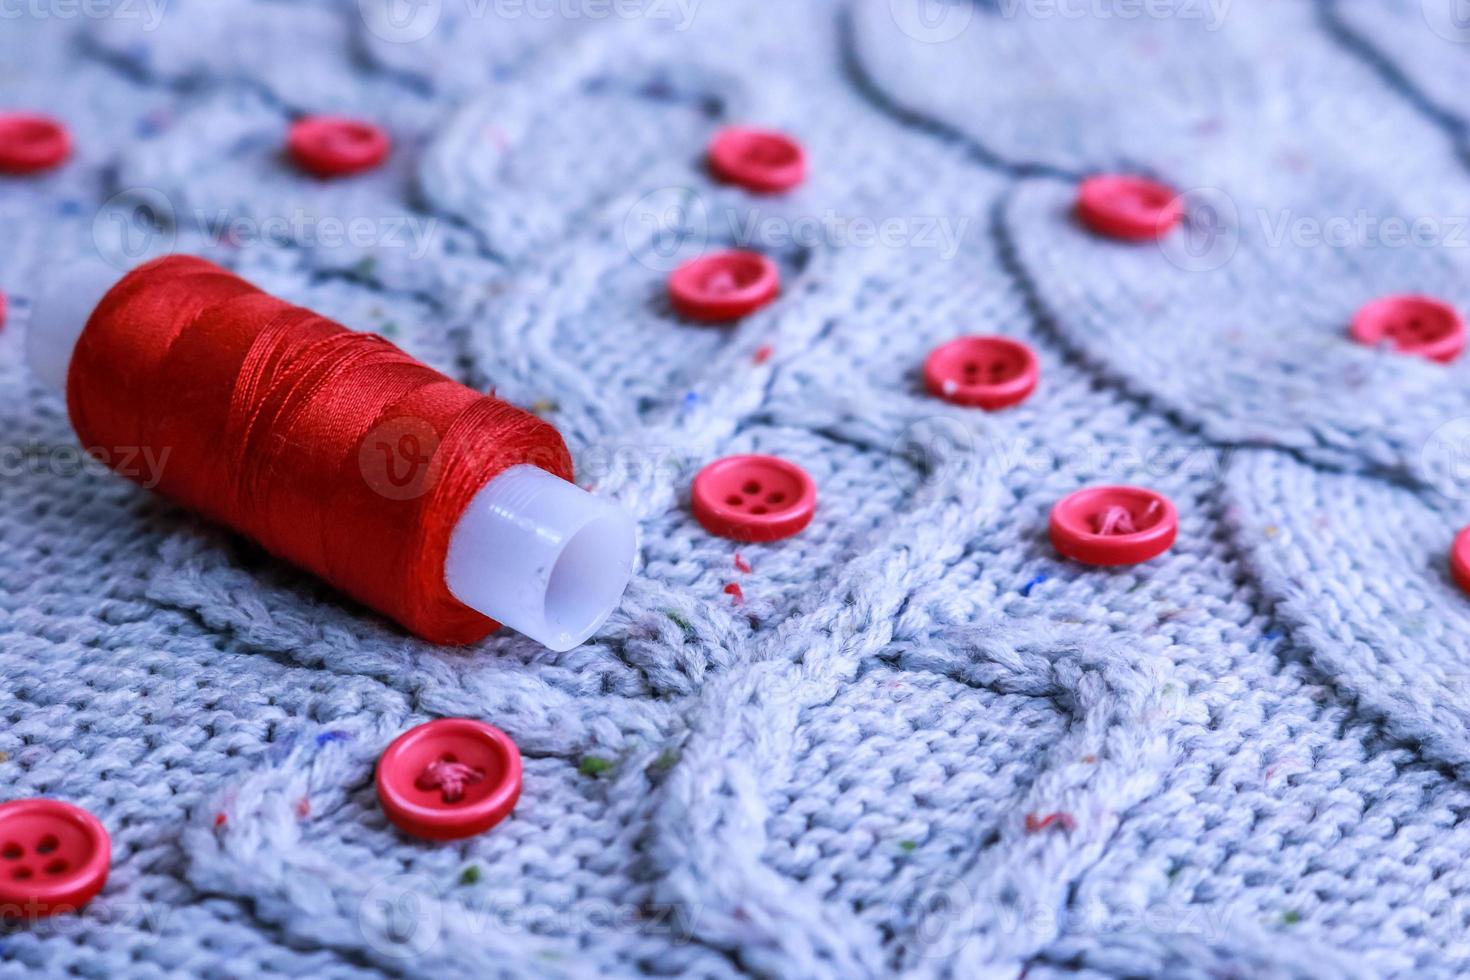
[444,466,637,652]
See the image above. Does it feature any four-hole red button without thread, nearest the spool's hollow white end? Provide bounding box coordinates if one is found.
[694,455,817,541]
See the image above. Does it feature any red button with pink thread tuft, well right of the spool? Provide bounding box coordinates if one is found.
[1051,486,1179,564]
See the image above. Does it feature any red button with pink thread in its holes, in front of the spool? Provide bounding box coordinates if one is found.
[378,718,520,840]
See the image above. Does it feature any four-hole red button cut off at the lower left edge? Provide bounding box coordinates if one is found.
[0,799,112,918]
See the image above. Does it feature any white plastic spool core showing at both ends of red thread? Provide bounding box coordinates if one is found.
[25,263,637,652]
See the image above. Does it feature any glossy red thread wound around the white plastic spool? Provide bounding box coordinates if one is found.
[66,256,572,644]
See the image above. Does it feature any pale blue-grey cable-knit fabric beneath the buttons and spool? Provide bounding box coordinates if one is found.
[0,0,1470,980]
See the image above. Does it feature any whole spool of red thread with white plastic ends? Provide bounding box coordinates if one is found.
[28,256,634,649]
